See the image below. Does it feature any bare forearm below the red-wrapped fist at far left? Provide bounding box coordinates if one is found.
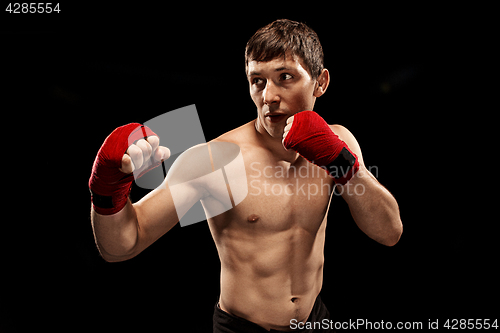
[91,200,138,262]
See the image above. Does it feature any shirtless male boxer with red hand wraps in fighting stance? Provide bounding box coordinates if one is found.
[89,20,402,332]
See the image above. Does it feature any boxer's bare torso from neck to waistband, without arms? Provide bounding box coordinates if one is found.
[208,121,333,330]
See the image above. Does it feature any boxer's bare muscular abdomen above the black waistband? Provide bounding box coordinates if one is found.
[216,218,326,330]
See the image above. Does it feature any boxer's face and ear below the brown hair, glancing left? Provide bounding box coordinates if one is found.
[247,56,329,140]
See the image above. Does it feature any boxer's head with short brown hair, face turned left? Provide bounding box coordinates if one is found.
[245,20,330,138]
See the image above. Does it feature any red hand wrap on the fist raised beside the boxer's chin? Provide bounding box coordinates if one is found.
[283,111,359,185]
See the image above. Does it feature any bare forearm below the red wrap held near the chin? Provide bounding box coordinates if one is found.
[339,165,403,246]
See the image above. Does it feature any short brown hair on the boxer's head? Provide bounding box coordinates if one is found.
[245,19,324,79]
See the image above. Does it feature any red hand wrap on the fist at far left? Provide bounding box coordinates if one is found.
[89,123,161,215]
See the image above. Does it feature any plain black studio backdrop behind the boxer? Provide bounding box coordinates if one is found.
[0,4,498,332]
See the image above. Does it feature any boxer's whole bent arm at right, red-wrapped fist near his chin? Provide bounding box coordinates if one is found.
[283,111,403,246]
